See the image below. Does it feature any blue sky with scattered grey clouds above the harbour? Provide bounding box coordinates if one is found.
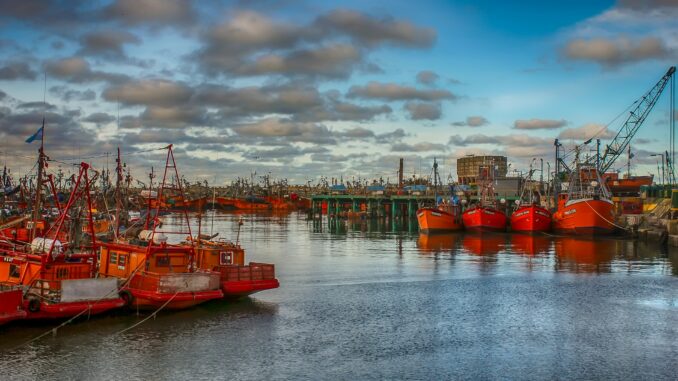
[0,0,678,184]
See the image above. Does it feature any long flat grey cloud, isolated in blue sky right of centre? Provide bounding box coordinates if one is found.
[347,82,457,101]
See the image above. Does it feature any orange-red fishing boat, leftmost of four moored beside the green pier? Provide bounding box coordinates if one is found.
[417,158,464,233]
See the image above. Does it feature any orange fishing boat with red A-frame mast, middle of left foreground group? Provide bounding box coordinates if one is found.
[99,145,223,310]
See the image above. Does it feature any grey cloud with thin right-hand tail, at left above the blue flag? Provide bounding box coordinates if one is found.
[44,57,129,83]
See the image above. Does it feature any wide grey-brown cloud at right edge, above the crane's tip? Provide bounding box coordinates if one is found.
[562,37,675,68]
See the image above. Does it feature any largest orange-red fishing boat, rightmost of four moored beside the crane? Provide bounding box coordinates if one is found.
[553,165,615,236]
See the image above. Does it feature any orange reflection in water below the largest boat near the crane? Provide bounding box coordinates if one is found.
[554,237,623,273]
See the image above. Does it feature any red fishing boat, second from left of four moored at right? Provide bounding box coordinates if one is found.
[462,161,507,232]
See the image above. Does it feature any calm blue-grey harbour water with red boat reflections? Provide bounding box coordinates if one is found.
[0,213,678,380]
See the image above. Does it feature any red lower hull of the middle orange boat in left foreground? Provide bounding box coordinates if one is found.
[127,288,224,310]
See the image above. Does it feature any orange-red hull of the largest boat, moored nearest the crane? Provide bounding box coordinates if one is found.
[553,199,615,236]
